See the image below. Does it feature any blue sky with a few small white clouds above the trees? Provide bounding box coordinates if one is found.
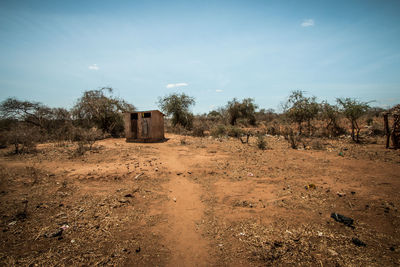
[0,0,400,113]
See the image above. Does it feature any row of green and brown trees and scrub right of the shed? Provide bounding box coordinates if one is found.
[159,90,384,143]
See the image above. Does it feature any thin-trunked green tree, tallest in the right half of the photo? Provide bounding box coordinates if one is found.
[284,90,319,135]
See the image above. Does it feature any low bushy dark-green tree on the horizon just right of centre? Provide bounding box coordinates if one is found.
[226,98,258,125]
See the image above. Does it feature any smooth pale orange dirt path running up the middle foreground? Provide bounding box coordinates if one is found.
[160,147,210,266]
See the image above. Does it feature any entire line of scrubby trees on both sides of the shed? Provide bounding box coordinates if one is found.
[0,87,394,153]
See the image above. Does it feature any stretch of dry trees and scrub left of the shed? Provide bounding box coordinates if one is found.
[0,87,135,153]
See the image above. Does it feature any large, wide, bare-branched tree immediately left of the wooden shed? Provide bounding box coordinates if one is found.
[72,87,135,137]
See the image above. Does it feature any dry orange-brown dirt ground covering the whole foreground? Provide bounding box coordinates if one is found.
[0,134,400,266]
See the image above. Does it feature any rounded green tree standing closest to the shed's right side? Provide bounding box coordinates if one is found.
[158,93,196,129]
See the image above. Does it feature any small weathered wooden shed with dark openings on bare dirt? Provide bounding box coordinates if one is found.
[124,110,164,142]
